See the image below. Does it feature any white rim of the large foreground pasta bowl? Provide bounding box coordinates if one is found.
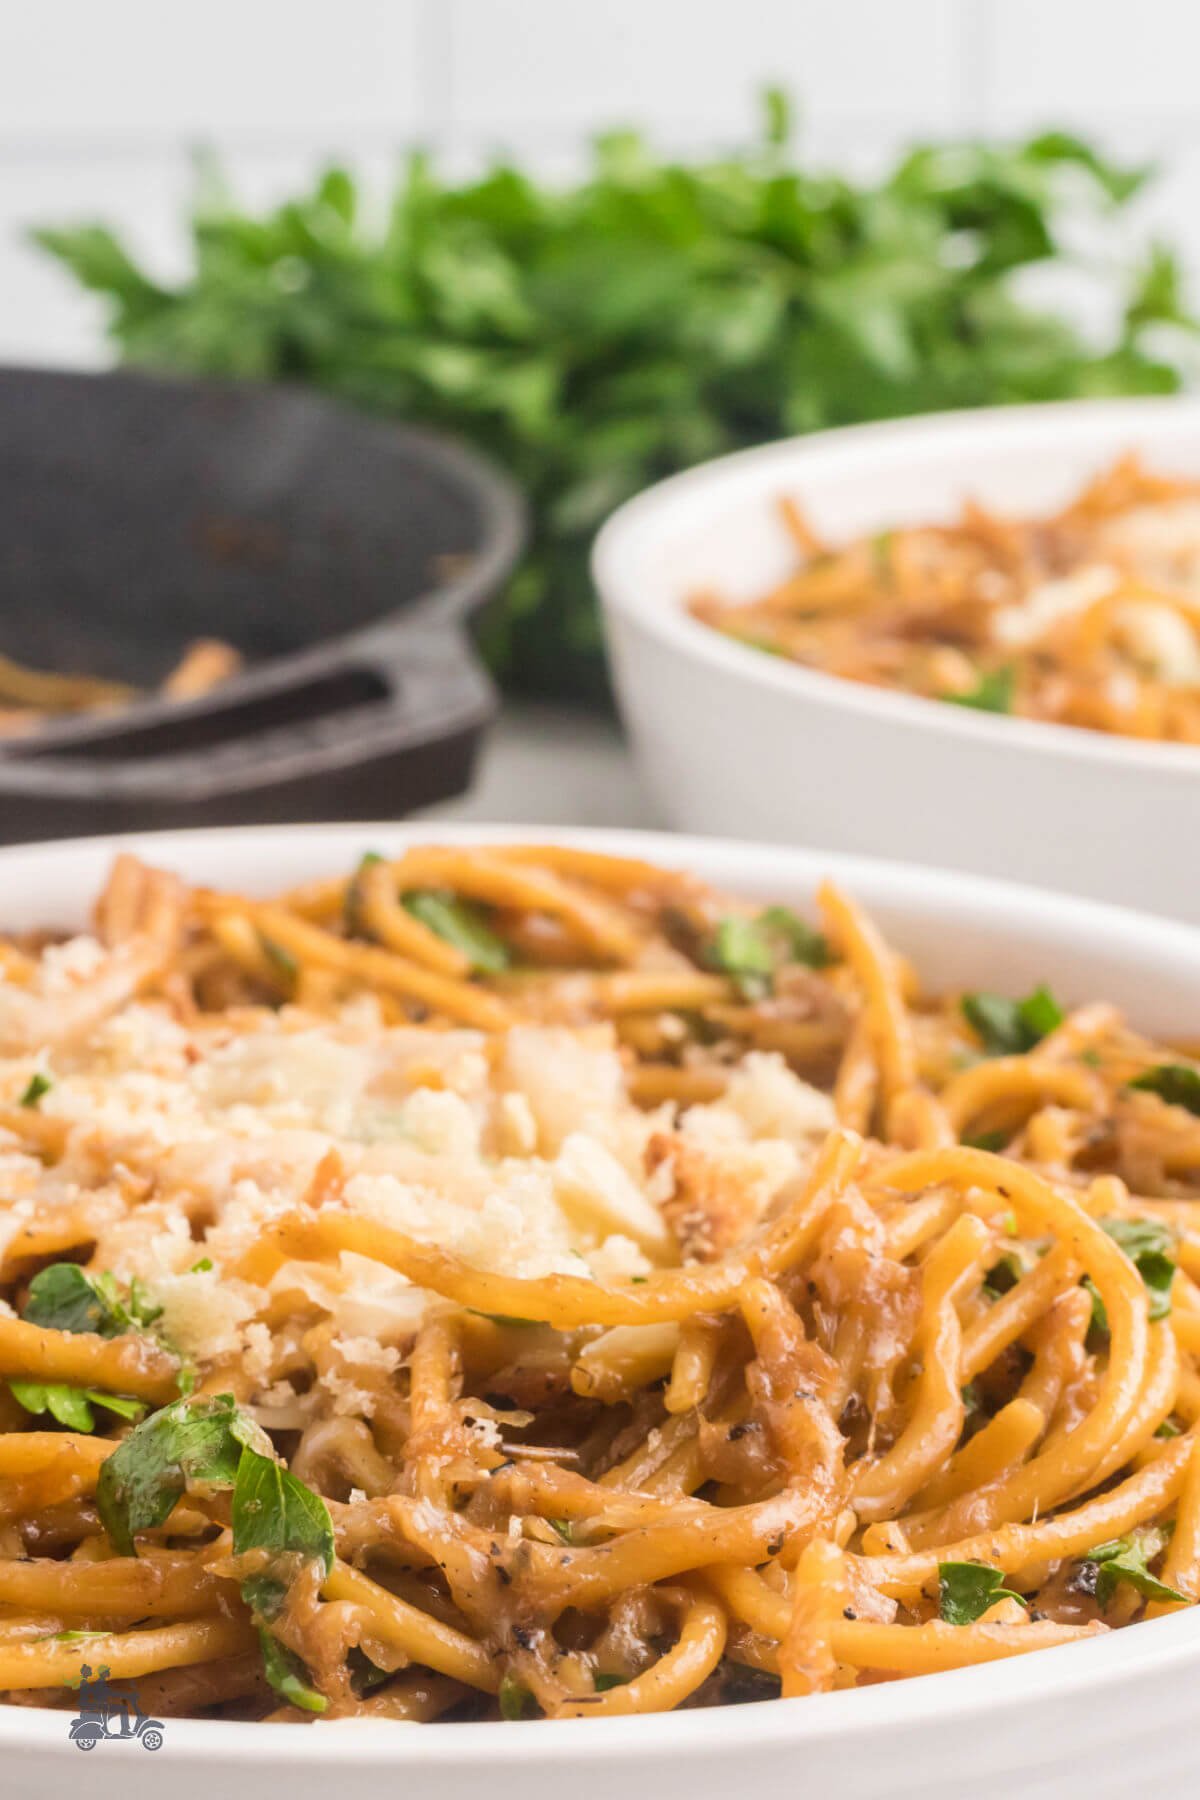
[0,823,1200,1778]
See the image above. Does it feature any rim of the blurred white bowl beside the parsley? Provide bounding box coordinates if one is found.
[592,398,1200,774]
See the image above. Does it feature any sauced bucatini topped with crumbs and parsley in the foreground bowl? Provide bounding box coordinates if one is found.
[0,844,1200,1721]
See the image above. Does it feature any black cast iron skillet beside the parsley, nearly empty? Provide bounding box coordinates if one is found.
[0,369,524,842]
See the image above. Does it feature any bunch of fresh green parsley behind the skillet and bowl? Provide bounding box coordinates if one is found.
[36,94,1193,706]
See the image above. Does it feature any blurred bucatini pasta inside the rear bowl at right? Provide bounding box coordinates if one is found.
[693,457,1200,743]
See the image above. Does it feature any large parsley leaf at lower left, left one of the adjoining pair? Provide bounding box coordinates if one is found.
[95,1393,270,1557]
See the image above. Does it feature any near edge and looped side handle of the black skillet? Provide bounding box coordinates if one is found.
[0,625,497,841]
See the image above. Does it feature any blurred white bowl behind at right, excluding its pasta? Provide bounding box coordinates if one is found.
[594,400,1200,920]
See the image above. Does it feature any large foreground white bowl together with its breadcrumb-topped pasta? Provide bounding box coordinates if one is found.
[0,826,1200,1800]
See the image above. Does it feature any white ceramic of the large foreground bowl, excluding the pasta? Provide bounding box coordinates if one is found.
[0,824,1200,1800]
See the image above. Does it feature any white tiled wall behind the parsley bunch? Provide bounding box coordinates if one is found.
[0,0,1200,362]
